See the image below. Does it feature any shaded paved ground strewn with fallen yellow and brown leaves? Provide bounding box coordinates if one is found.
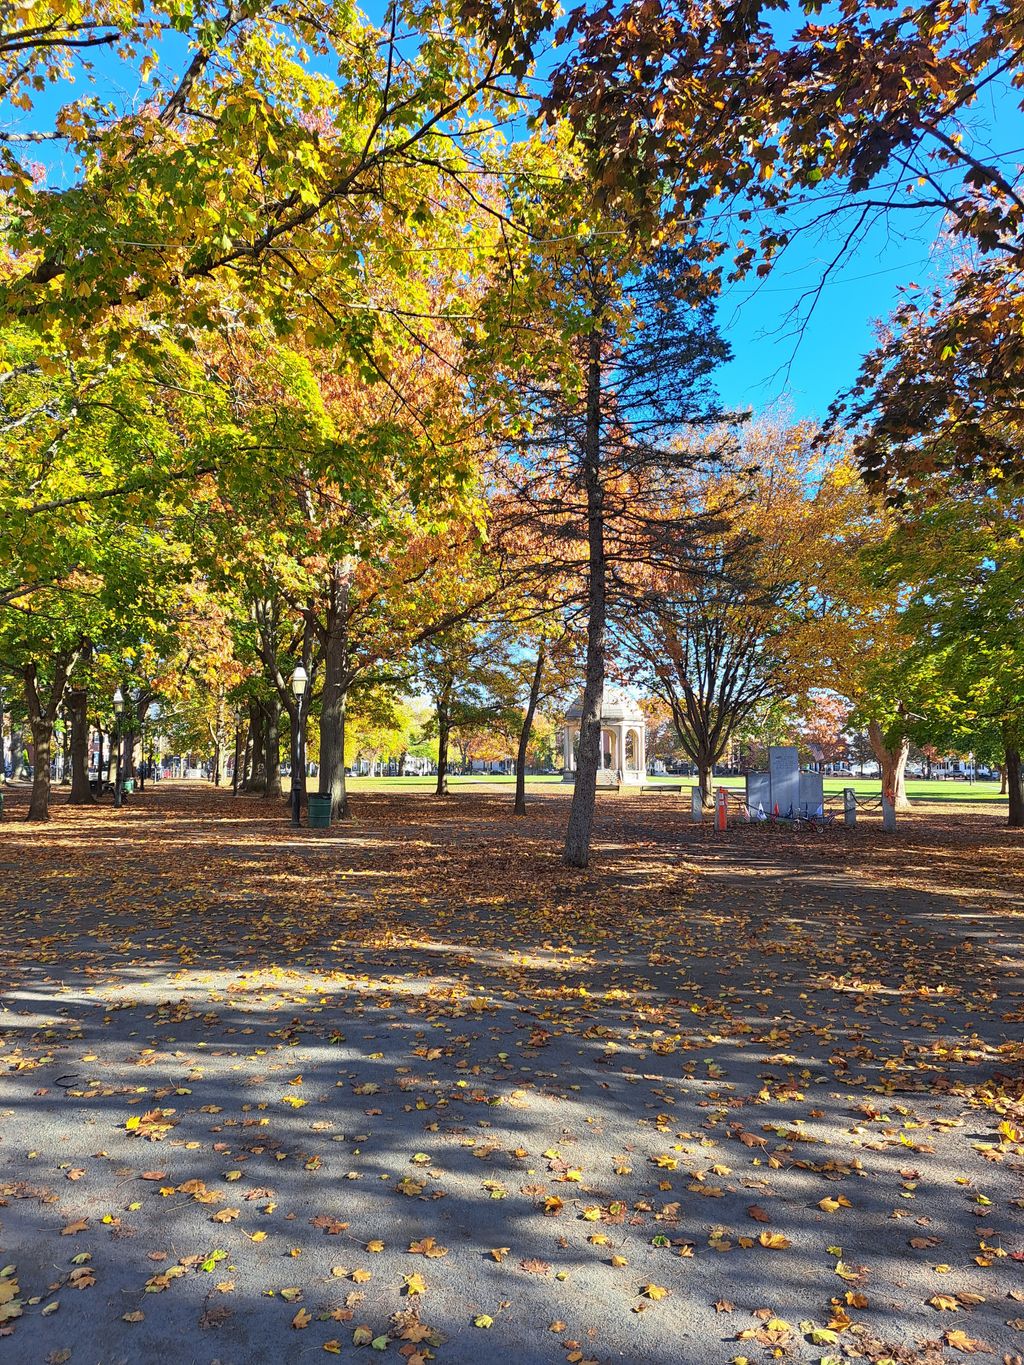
[0,785,1024,1365]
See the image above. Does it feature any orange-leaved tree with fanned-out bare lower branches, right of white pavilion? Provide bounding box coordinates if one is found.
[621,422,868,801]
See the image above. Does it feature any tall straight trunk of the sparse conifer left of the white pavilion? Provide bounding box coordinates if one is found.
[565,329,608,867]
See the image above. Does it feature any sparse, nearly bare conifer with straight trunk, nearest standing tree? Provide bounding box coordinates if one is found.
[480,220,728,867]
